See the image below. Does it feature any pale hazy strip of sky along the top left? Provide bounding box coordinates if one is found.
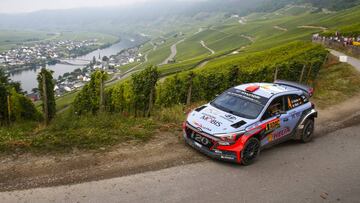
[0,0,154,13]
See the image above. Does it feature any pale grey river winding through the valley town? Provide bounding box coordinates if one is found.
[10,38,139,93]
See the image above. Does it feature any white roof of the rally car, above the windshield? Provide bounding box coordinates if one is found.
[234,83,301,98]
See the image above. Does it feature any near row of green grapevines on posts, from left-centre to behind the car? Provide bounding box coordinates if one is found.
[74,42,327,116]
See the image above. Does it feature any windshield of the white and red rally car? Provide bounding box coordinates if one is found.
[210,92,264,119]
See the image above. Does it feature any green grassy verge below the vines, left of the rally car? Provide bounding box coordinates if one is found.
[0,112,158,153]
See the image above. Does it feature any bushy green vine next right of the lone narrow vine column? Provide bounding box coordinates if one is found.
[74,71,107,115]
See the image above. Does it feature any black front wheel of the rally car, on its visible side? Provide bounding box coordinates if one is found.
[241,138,260,166]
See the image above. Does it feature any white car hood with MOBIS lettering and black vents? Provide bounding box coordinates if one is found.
[187,104,255,136]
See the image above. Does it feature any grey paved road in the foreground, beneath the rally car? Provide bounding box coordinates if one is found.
[0,123,360,203]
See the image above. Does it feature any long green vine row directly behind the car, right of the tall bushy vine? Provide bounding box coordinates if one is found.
[157,42,327,106]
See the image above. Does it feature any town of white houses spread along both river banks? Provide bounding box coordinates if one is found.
[0,38,143,101]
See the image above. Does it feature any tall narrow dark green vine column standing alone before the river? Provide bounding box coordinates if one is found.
[37,68,56,125]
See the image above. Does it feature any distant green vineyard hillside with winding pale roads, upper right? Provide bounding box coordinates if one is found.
[133,5,360,76]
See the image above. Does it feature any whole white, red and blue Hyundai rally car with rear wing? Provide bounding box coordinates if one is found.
[183,80,318,165]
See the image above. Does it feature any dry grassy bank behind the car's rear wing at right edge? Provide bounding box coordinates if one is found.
[313,57,360,109]
